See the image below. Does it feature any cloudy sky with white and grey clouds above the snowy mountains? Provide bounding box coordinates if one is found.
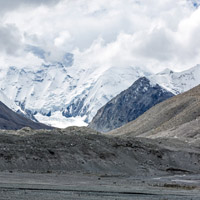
[0,0,200,72]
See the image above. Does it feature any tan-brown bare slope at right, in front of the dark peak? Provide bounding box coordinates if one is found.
[110,85,200,137]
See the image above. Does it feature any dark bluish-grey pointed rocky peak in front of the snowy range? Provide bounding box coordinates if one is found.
[89,77,174,132]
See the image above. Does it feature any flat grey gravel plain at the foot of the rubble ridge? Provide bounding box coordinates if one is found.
[0,172,200,200]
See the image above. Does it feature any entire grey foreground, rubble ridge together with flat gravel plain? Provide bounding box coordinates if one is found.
[0,127,200,200]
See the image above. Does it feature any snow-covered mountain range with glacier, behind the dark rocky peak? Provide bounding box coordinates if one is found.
[0,61,200,127]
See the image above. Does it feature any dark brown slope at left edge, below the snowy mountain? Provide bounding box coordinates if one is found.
[0,102,51,130]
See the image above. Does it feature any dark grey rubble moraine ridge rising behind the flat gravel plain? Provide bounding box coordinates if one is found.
[0,127,200,176]
